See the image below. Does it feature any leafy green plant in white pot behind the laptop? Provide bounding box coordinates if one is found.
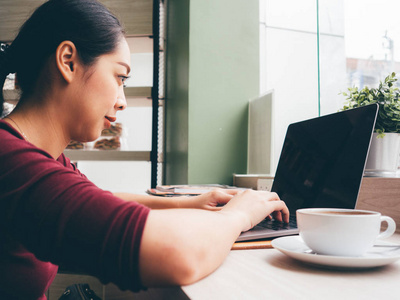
[341,72,400,173]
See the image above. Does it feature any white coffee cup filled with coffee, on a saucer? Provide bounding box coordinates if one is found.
[296,208,396,256]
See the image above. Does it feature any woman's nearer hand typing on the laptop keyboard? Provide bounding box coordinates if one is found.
[221,190,289,231]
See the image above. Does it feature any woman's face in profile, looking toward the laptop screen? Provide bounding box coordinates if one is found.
[71,38,130,142]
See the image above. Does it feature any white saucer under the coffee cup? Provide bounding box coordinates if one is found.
[272,235,400,268]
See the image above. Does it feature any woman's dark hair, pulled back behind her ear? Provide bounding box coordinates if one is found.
[0,0,124,115]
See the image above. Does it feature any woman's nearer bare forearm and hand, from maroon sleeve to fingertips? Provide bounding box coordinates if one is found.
[139,190,289,286]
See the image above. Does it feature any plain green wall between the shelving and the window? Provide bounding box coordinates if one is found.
[165,0,259,184]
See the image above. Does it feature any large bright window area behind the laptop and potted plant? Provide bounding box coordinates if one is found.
[260,0,400,173]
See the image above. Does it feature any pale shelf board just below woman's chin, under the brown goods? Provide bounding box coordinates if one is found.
[64,149,150,161]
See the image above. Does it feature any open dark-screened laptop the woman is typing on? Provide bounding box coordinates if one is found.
[237,104,378,241]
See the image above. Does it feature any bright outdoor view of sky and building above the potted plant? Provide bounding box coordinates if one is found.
[344,0,400,87]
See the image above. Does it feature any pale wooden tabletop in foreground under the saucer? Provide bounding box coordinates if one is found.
[182,234,400,300]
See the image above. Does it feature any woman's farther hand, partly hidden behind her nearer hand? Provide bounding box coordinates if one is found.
[177,189,242,211]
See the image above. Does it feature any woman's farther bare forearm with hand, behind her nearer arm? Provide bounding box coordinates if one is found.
[114,189,240,211]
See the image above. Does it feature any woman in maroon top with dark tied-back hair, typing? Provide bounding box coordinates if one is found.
[0,0,288,299]
